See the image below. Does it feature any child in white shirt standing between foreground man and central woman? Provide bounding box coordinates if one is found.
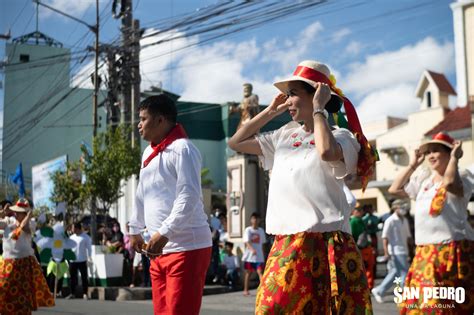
[242,212,266,296]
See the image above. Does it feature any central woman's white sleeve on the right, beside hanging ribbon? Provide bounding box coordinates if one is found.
[329,128,360,179]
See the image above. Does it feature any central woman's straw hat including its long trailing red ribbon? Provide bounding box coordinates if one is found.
[274,60,379,191]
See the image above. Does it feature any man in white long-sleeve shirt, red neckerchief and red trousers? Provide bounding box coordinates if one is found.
[130,94,212,314]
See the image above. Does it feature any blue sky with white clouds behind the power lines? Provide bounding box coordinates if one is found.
[0,0,456,132]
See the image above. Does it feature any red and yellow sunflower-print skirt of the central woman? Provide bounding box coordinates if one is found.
[255,231,372,315]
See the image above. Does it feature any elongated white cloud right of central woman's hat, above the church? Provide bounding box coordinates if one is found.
[341,37,454,96]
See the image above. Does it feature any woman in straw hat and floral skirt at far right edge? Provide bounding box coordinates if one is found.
[389,132,474,314]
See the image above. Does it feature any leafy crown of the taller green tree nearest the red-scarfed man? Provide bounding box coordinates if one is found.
[82,125,141,212]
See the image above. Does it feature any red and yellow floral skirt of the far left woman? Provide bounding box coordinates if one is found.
[0,256,54,315]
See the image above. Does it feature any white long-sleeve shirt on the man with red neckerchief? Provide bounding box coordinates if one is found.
[129,139,212,254]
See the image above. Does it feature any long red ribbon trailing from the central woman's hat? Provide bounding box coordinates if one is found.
[293,66,378,191]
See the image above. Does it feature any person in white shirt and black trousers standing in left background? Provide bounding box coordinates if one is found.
[67,223,92,300]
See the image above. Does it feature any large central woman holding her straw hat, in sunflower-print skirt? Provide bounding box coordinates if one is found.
[229,61,376,314]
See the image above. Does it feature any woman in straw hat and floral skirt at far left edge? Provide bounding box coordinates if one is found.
[0,199,54,315]
